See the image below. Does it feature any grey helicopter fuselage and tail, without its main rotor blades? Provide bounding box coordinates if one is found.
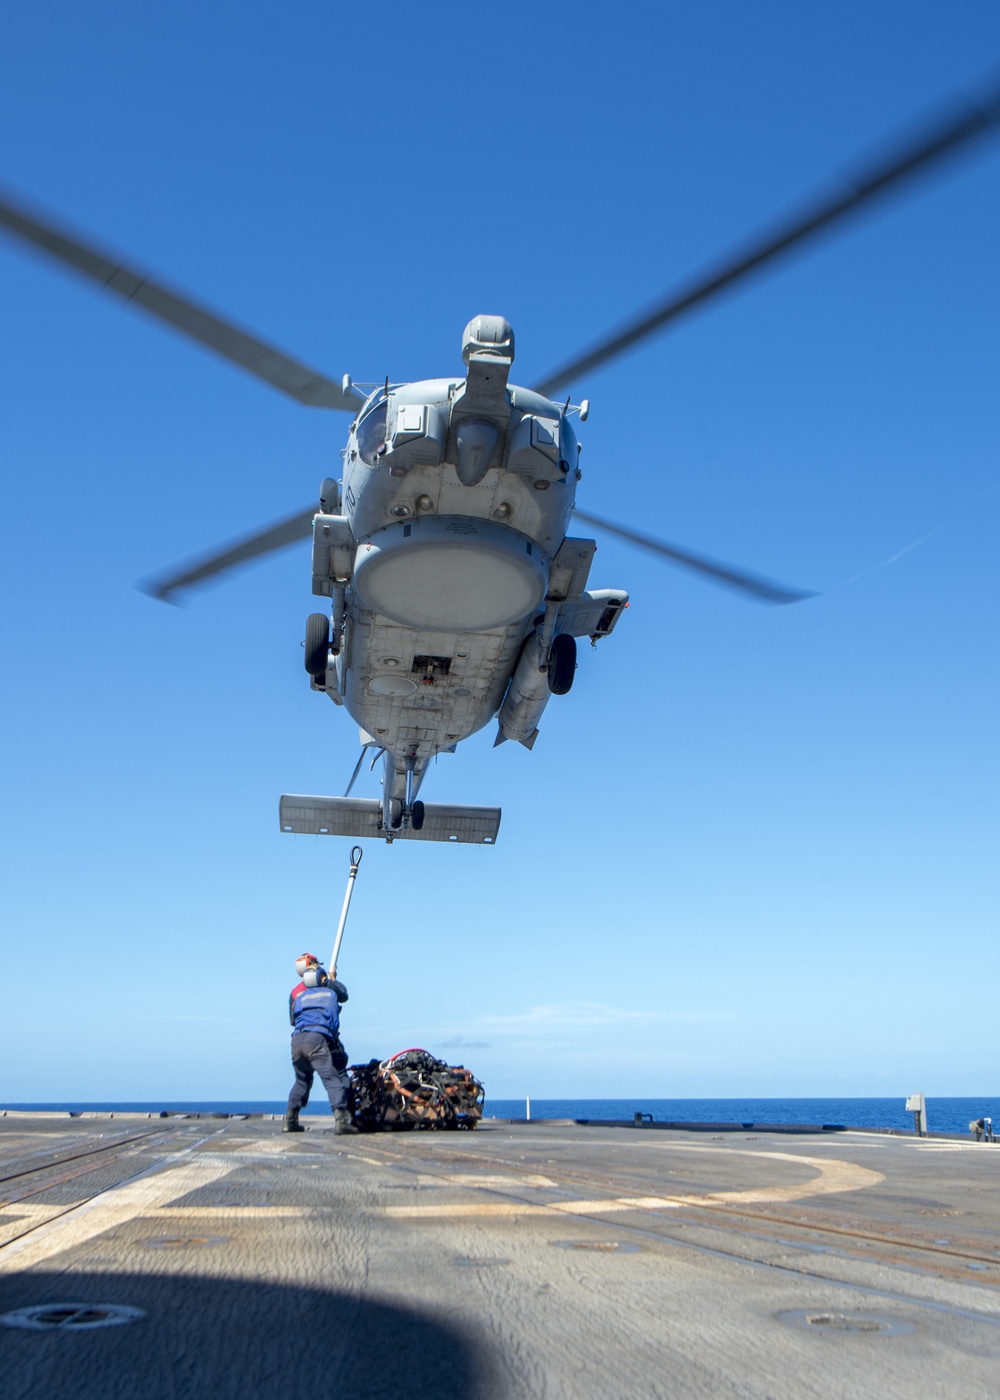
[280,316,627,844]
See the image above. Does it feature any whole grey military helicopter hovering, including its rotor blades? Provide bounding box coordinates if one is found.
[0,76,1000,844]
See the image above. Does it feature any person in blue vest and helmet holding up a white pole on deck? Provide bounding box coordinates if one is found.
[284,953,357,1133]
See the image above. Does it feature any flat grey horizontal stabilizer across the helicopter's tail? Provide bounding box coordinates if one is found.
[280,792,500,846]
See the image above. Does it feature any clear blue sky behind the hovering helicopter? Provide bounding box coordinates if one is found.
[0,0,1000,1100]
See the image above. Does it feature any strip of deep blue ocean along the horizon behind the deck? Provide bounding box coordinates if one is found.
[0,1091,1000,1133]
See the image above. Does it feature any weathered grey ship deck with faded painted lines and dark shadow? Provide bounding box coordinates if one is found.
[0,1114,1000,1400]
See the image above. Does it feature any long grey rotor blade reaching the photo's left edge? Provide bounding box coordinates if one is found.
[0,193,360,413]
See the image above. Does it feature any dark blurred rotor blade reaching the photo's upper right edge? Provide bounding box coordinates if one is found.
[535,75,1000,398]
